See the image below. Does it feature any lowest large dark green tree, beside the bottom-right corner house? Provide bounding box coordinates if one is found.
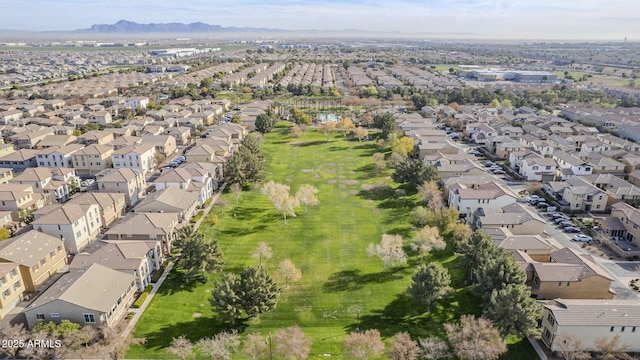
[484,284,542,339]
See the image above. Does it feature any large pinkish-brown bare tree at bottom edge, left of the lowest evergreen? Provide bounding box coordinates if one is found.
[444,315,507,360]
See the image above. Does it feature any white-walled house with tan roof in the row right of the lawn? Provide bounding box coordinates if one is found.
[449,181,518,216]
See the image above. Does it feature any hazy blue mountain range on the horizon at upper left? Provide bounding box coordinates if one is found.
[80,20,278,33]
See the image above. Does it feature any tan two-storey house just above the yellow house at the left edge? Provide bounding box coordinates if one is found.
[0,230,67,292]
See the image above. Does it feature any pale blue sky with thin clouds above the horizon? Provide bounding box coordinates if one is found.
[0,0,640,41]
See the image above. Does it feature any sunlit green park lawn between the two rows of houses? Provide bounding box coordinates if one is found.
[127,126,535,359]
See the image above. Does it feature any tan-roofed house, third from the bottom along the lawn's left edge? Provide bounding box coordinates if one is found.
[104,212,179,255]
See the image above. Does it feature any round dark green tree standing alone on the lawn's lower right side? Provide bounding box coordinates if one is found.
[409,262,451,311]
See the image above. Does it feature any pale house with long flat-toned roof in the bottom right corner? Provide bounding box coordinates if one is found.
[541,299,640,353]
